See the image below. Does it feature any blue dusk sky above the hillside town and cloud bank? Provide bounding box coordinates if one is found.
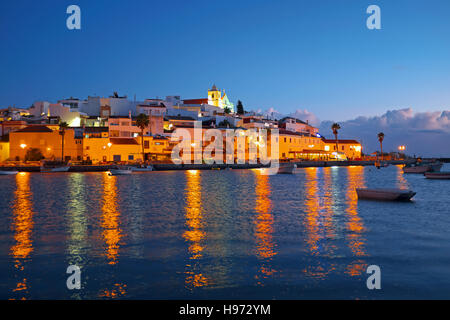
[0,0,450,121]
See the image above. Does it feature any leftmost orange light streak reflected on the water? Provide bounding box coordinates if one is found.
[10,172,34,299]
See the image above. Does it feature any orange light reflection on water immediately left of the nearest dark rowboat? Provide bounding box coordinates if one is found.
[346,166,367,276]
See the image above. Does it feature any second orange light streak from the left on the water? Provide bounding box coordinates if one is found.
[101,174,122,265]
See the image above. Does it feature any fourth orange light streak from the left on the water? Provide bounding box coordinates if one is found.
[254,170,277,284]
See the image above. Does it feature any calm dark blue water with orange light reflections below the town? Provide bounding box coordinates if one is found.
[0,166,450,299]
